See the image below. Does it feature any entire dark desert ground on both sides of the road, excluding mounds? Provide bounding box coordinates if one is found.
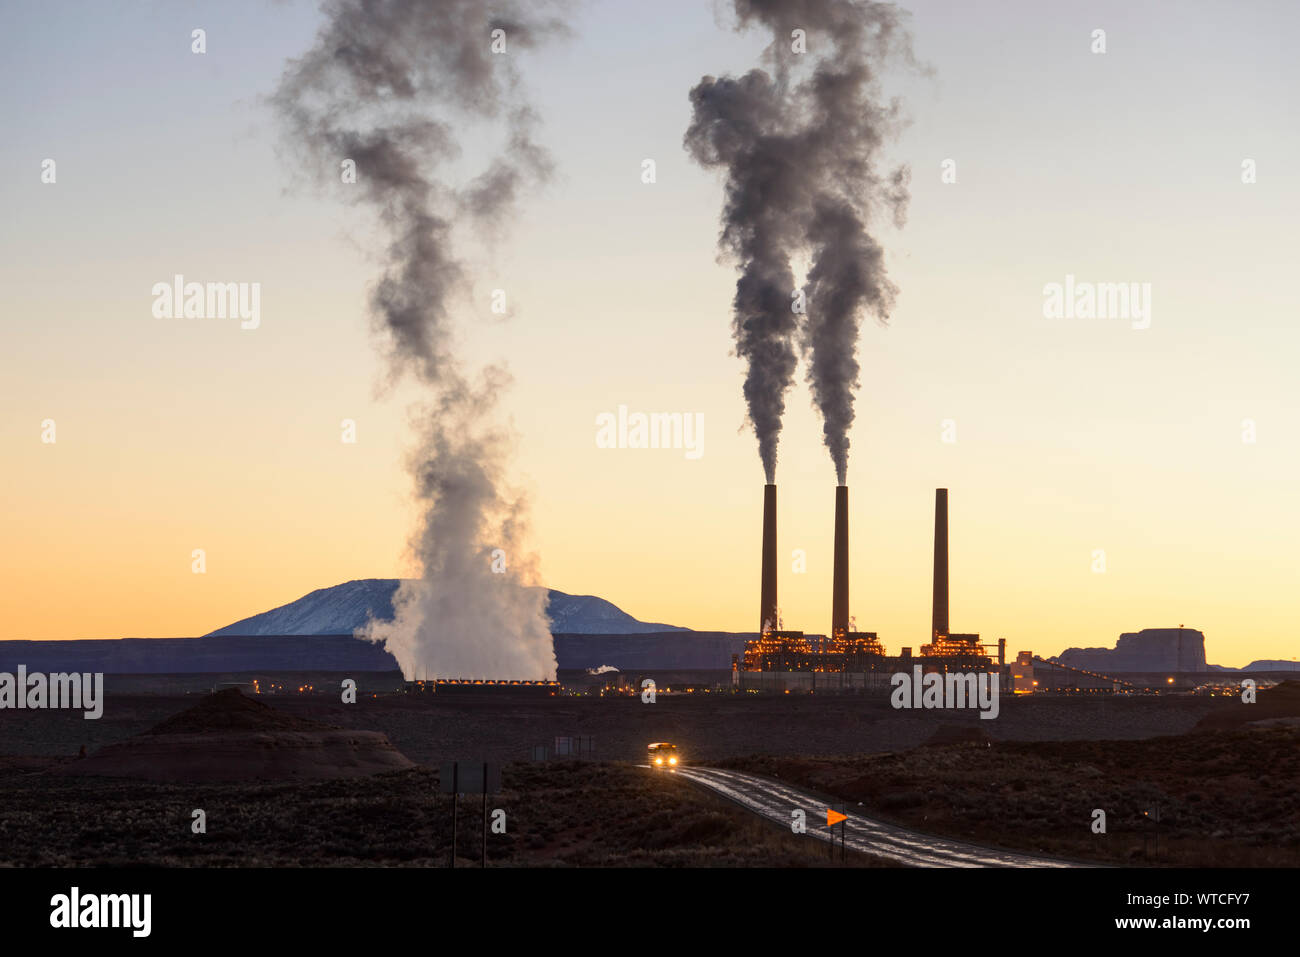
[0,685,1279,866]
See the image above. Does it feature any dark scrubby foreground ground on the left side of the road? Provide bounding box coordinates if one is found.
[0,758,878,867]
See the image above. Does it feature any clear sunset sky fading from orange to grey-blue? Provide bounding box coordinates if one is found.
[0,0,1300,666]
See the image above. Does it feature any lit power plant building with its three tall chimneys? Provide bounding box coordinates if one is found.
[737,485,1006,689]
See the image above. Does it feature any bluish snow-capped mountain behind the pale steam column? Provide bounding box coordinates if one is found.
[204,579,689,637]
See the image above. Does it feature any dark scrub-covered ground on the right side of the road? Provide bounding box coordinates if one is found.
[723,681,1300,867]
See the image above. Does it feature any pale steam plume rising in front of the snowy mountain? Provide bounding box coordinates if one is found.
[272,0,563,679]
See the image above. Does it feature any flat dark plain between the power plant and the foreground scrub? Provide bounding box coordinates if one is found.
[0,685,1222,767]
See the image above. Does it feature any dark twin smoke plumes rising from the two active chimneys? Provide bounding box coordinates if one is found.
[685,0,913,485]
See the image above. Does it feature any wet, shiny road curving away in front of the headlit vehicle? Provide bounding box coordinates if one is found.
[676,767,1088,867]
